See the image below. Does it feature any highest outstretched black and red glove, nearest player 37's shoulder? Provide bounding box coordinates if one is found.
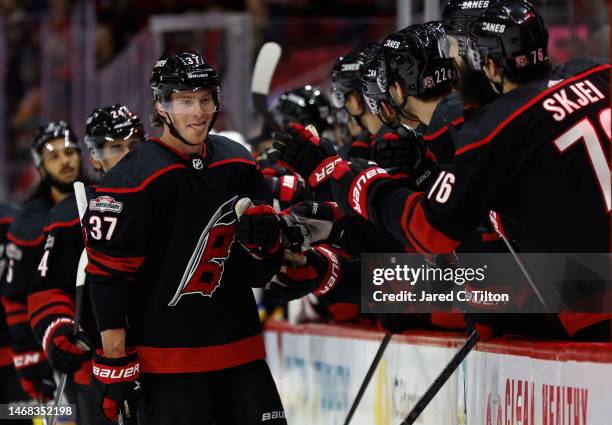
[273,124,340,187]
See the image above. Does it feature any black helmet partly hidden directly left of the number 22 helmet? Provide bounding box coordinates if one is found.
[359,55,399,127]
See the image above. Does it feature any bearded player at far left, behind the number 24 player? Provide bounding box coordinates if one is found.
[2,121,82,400]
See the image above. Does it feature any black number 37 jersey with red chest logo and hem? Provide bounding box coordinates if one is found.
[84,135,280,373]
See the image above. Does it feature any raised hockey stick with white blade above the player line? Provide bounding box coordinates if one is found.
[251,41,282,129]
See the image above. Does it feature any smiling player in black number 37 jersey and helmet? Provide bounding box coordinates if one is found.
[85,52,286,425]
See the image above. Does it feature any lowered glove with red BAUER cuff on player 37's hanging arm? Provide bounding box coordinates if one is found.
[91,350,140,422]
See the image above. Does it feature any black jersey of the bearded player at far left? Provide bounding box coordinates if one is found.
[2,193,54,351]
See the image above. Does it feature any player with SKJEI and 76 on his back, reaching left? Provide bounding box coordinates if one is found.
[332,0,611,339]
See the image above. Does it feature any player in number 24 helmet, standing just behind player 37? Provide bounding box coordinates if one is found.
[28,105,144,424]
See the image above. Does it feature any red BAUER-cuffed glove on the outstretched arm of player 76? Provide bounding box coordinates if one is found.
[331,159,393,224]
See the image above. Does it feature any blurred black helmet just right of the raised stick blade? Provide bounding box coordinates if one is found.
[272,85,334,133]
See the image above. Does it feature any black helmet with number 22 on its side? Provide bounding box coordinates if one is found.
[381,23,457,108]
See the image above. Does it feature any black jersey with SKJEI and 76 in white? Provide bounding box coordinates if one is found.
[380,61,612,253]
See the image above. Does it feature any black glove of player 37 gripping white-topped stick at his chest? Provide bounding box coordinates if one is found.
[235,198,281,259]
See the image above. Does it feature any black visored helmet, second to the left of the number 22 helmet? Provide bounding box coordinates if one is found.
[330,43,378,108]
